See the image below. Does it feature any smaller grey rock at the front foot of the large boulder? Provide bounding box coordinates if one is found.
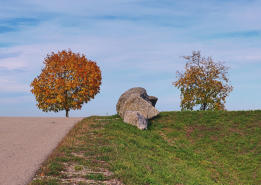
[124,111,148,130]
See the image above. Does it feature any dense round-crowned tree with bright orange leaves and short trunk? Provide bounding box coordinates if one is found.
[31,49,102,117]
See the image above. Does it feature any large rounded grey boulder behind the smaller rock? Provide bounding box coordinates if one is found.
[116,87,159,128]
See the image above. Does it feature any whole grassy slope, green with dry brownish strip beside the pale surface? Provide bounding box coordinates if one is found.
[31,111,261,185]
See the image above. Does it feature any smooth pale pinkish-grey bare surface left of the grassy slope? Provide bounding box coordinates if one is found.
[0,117,82,185]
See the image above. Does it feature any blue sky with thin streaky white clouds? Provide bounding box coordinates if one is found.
[0,0,261,117]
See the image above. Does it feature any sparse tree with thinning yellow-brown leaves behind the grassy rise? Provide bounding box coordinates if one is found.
[173,51,233,110]
